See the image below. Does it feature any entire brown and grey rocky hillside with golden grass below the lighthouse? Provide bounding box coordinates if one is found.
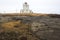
[0,14,60,40]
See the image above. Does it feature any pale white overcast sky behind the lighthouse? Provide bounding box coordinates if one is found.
[0,0,60,14]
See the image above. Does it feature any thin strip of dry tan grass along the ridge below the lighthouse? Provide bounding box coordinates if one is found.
[1,13,48,16]
